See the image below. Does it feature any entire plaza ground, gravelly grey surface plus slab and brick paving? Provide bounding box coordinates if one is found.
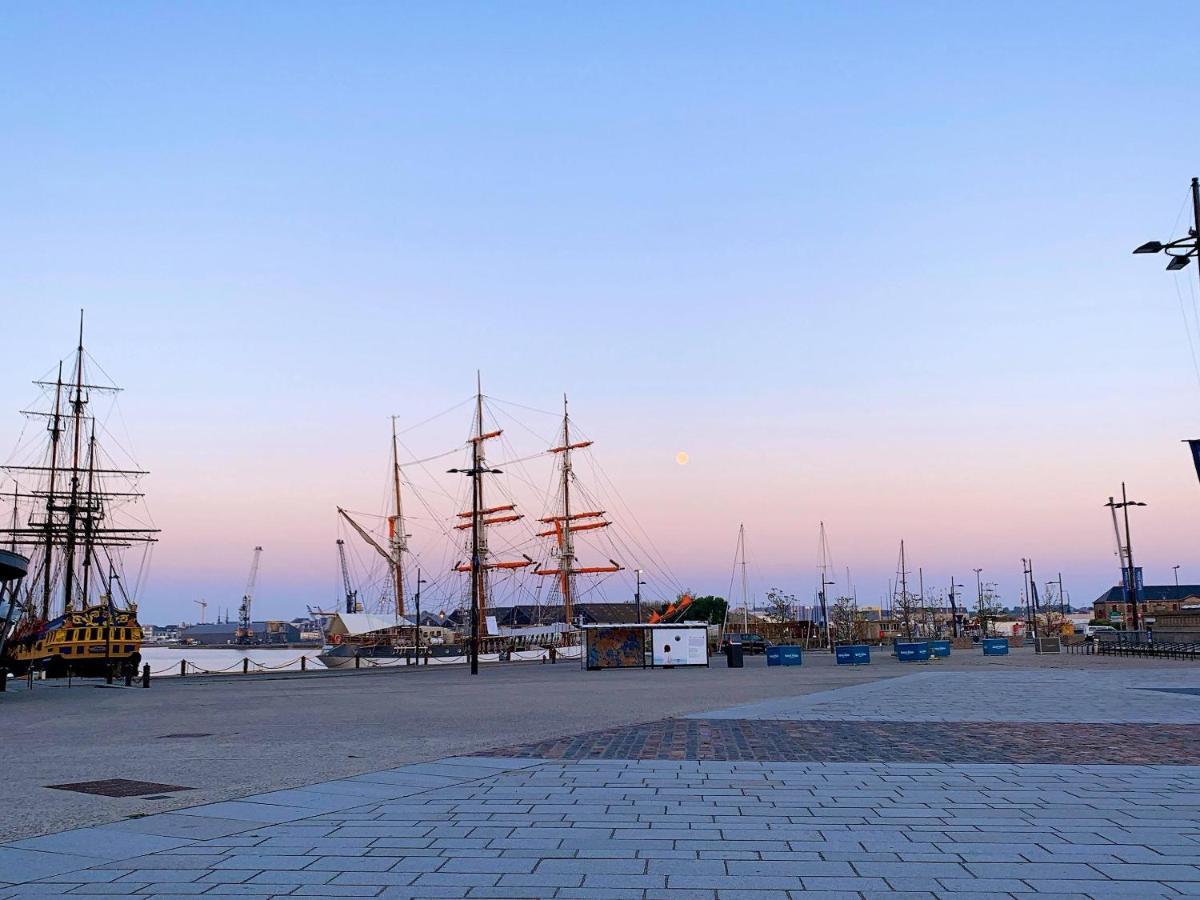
[0,650,1200,900]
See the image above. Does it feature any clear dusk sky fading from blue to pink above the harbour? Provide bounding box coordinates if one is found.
[0,1,1200,622]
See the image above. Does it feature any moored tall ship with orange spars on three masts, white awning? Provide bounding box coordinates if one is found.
[319,384,622,668]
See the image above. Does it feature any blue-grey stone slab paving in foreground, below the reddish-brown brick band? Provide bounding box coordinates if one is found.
[0,757,1200,900]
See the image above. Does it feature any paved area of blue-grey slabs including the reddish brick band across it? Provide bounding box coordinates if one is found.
[0,667,1200,900]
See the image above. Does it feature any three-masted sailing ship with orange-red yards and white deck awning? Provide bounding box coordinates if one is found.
[319,384,622,667]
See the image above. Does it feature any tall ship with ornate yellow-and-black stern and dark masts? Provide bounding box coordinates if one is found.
[0,313,158,677]
